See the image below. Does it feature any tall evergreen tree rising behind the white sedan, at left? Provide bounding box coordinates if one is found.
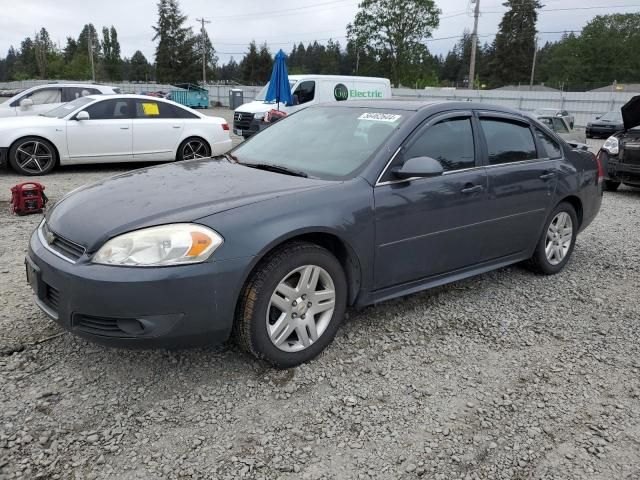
[153,0,200,83]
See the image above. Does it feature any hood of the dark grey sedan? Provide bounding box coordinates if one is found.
[46,159,335,252]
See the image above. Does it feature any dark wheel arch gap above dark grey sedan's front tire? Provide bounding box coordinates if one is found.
[237,229,362,312]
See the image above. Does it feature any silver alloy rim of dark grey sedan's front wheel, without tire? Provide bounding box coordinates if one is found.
[266,265,336,353]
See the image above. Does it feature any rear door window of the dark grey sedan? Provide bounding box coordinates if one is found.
[480,118,538,165]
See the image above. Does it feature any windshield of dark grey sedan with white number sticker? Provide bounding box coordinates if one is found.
[232,107,410,180]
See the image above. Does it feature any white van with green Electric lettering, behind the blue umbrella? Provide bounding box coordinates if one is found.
[233,75,391,138]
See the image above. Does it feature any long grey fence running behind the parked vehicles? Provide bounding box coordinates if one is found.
[0,80,636,127]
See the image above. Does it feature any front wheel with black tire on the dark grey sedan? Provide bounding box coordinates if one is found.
[234,242,347,368]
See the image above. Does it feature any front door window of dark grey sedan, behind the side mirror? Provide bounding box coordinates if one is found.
[403,117,476,172]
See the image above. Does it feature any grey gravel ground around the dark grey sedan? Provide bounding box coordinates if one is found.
[0,117,640,480]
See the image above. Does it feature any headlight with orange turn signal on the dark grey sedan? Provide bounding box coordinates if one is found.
[93,223,224,267]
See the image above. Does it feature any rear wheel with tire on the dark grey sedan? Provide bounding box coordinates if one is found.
[530,202,578,275]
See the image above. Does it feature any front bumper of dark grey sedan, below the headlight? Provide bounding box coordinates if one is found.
[25,230,251,348]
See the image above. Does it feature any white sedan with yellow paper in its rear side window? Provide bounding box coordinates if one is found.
[0,95,231,175]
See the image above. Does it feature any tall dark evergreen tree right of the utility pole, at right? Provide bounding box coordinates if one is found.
[491,0,542,85]
